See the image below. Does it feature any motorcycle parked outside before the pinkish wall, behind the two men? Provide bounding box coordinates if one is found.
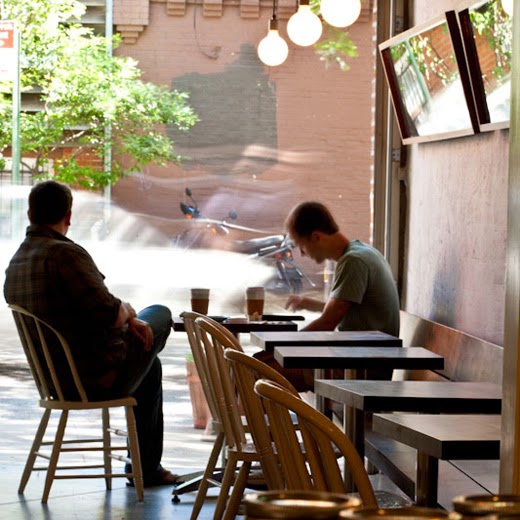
[176,188,315,294]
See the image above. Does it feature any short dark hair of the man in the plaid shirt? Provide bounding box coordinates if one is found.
[29,181,72,225]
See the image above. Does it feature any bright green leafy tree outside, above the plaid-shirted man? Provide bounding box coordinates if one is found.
[0,0,197,189]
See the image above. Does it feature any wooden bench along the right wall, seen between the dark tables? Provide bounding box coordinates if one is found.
[365,311,503,509]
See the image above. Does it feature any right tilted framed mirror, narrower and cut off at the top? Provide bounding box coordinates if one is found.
[457,0,513,131]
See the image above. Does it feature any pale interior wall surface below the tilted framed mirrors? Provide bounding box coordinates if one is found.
[402,0,509,345]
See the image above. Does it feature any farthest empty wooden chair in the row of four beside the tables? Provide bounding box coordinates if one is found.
[172,311,241,520]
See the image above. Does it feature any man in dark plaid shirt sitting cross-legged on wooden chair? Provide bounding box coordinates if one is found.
[4,181,176,486]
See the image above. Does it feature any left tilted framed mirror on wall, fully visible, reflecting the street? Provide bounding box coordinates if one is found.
[379,11,479,144]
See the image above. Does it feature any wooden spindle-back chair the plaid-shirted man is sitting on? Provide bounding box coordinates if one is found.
[9,305,143,504]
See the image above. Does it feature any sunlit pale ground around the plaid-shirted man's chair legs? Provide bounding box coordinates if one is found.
[0,296,414,520]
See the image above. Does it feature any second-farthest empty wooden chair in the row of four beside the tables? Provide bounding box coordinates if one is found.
[195,317,265,520]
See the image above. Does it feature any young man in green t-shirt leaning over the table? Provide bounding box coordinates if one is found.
[285,202,399,336]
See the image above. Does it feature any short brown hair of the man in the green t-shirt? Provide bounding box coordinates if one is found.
[285,201,339,238]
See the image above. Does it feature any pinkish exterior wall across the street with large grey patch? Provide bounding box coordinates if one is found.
[113,2,375,282]
